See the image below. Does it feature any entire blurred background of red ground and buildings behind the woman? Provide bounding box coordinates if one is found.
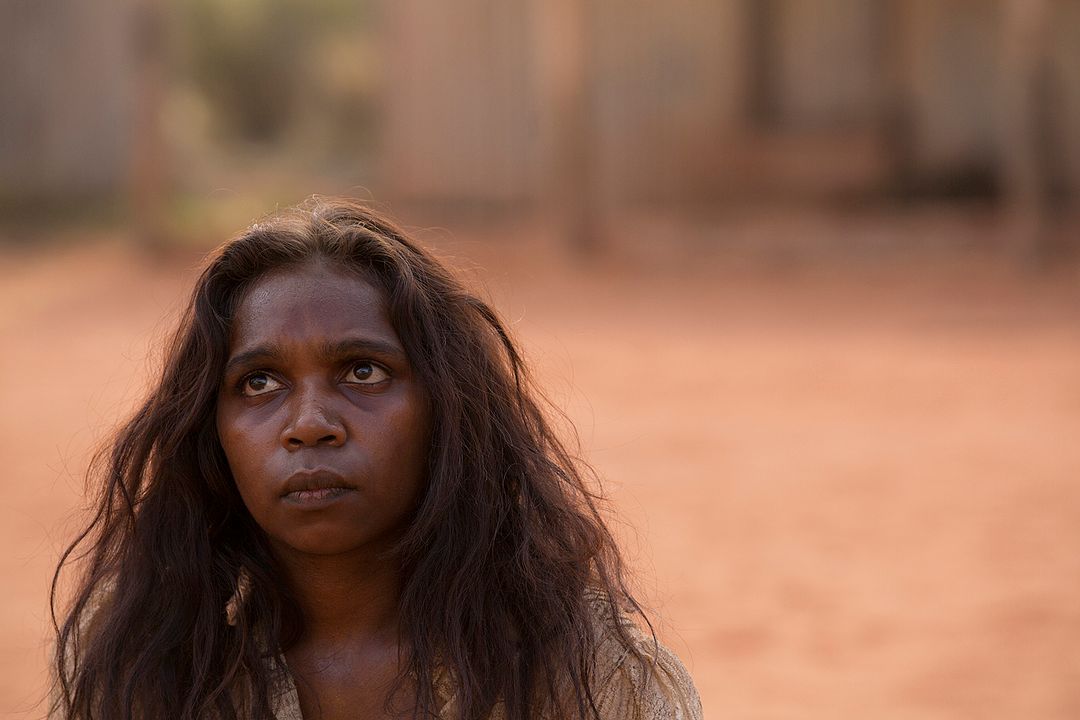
[0,0,1080,720]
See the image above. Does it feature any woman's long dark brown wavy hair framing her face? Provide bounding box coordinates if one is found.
[51,198,648,720]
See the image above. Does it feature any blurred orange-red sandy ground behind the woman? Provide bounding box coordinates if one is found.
[0,215,1080,720]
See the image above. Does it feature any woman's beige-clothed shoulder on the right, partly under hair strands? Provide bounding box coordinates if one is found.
[591,595,702,720]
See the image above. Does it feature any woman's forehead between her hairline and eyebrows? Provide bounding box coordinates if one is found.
[230,262,399,352]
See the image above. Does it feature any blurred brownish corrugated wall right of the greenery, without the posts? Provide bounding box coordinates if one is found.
[384,0,1080,207]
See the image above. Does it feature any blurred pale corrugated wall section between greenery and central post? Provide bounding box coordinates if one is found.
[380,0,539,202]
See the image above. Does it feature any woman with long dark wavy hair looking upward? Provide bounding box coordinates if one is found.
[53,199,701,720]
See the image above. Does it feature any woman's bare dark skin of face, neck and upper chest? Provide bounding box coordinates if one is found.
[217,262,431,720]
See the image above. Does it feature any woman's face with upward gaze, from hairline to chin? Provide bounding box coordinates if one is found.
[217,262,431,555]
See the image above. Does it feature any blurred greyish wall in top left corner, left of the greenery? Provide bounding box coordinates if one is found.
[0,0,134,196]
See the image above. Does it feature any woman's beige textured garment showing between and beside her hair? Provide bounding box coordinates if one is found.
[274,604,702,720]
